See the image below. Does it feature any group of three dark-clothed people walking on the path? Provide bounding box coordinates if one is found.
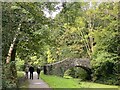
[25,65,42,79]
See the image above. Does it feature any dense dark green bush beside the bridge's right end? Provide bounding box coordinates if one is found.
[91,52,119,85]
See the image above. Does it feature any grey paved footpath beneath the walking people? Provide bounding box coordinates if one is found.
[28,72,50,90]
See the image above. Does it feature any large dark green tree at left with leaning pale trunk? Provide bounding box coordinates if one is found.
[2,3,50,88]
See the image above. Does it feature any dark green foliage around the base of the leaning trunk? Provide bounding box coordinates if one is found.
[2,62,18,89]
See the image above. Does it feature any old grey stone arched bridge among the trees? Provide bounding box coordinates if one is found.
[44,58,91,78]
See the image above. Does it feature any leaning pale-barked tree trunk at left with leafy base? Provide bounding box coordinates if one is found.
[4,23,21,88]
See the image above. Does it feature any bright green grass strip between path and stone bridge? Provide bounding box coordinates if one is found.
[41,72,118,88]
